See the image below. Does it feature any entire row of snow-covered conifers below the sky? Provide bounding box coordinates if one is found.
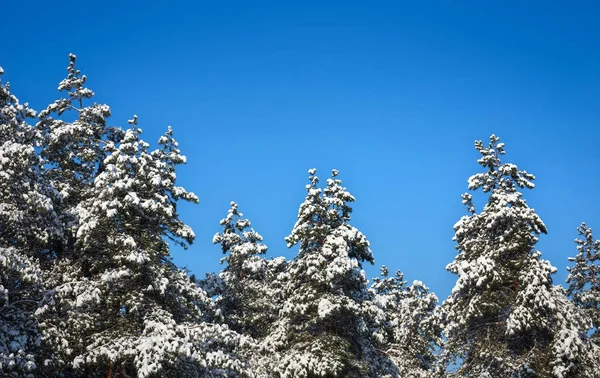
[0,54,600,378]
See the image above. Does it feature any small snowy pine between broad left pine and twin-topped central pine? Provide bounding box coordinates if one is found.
[213,202,284,340]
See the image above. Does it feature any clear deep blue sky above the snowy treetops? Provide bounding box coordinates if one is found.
[0,1,600,299]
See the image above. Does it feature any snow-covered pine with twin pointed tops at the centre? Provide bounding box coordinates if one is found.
[266,169,384,378]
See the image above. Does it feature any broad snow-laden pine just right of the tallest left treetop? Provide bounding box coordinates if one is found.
[41,117,245,377]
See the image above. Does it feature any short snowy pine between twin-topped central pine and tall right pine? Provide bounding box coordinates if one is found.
[371,266,442,378]
